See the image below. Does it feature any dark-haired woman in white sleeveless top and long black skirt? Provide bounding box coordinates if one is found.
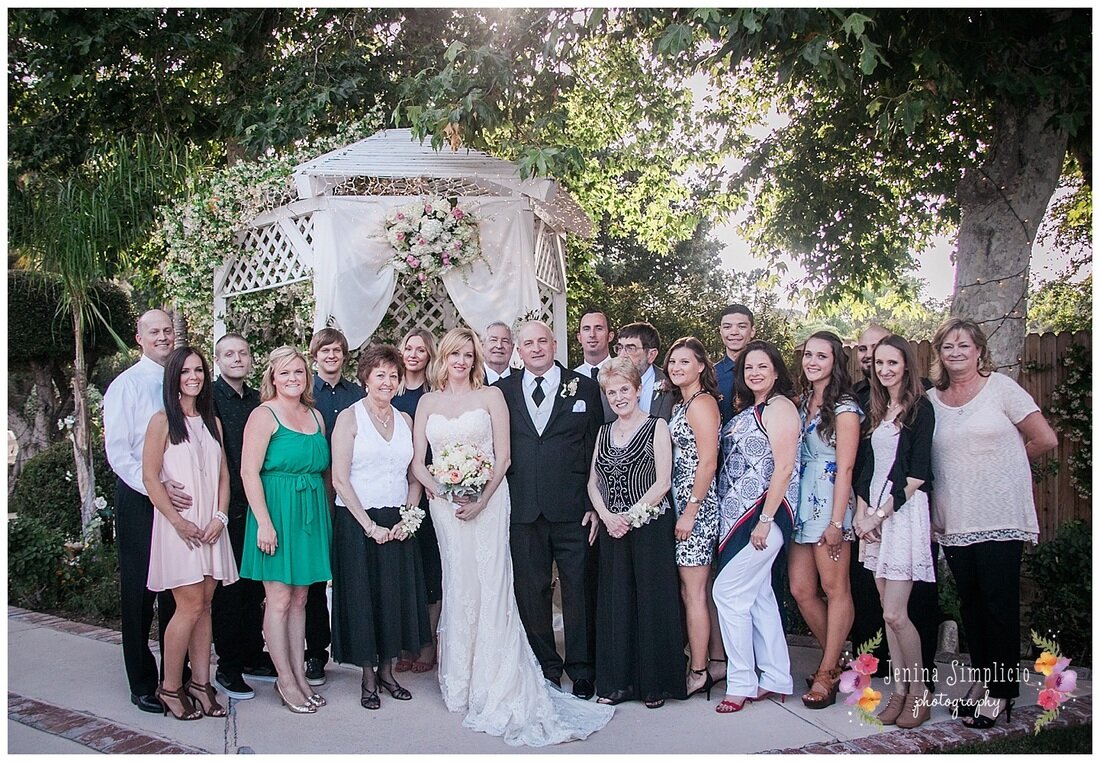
[332,345,431,709]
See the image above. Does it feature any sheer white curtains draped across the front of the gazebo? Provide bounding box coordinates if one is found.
[314,196,539,346]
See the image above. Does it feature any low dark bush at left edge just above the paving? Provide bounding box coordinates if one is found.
[8,514,65,608]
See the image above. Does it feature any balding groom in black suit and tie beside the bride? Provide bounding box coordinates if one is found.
[495,321,604,698]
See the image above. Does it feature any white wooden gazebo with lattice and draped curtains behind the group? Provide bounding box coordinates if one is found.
[213,130,592,360]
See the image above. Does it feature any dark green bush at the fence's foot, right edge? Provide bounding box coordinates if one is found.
[1023,521,1092,664]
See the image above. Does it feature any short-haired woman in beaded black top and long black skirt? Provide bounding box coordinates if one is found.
[589,357,685,709]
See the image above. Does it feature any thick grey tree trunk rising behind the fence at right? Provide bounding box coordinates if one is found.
[952,97,1067,378]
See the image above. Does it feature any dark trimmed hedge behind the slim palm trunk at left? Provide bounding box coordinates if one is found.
[8,269,138,366]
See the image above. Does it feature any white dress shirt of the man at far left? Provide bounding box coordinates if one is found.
[103,355,164,495]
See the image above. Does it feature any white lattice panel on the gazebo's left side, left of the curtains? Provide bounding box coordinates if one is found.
[221,213,314,297]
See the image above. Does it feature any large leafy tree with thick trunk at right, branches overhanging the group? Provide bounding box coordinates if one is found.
[402,9,1091,373]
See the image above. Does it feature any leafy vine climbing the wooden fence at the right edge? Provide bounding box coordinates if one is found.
[1046,344,1092,498]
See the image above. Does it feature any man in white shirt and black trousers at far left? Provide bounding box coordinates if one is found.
[103,310,182,713]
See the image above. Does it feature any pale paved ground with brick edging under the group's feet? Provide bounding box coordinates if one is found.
[8,608,1091,753]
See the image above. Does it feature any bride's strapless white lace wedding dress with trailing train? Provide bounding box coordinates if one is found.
[426,408,615,747]
